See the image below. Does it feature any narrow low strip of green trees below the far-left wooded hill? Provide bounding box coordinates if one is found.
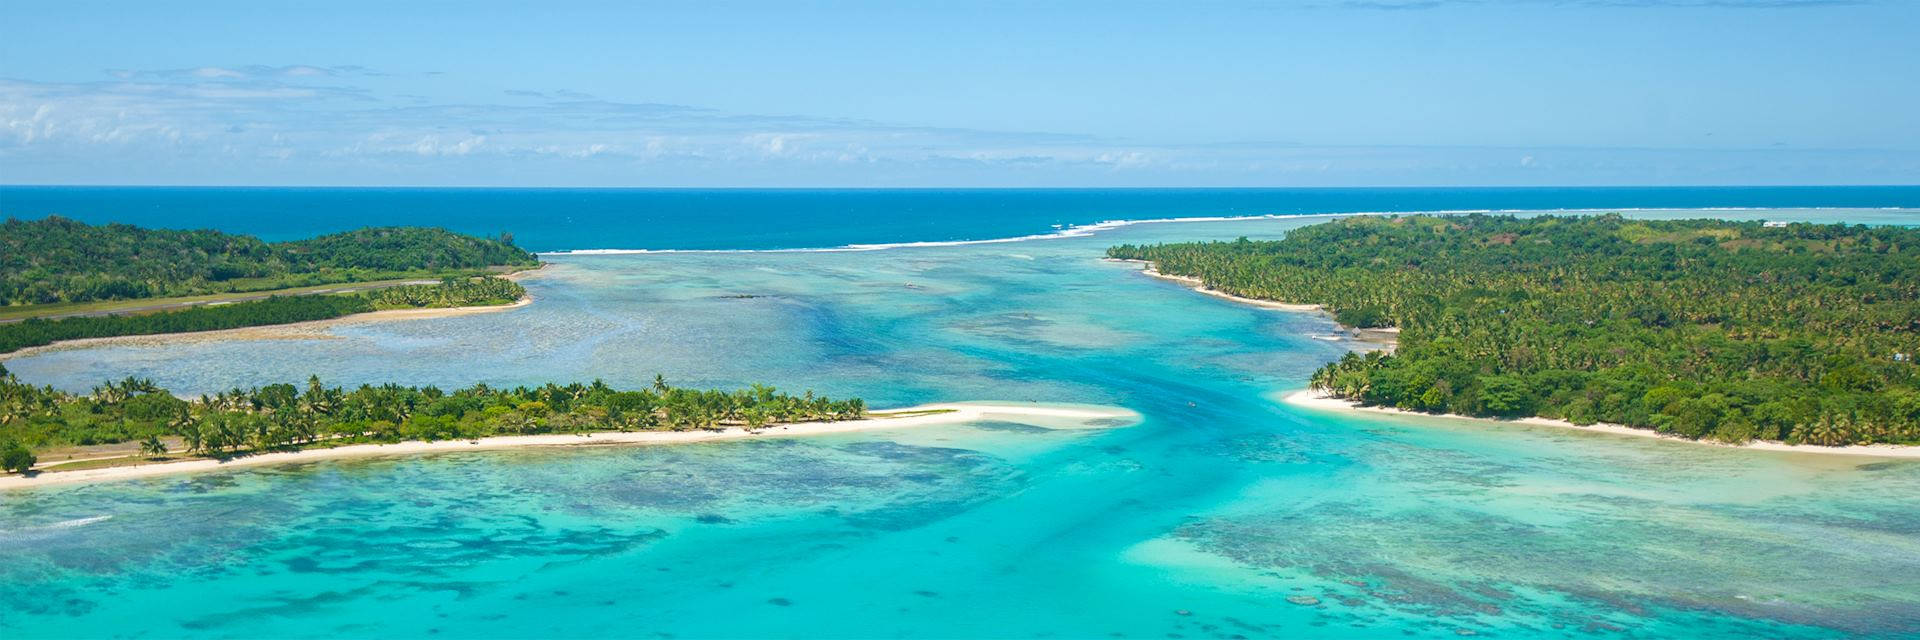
[0,277,526,354]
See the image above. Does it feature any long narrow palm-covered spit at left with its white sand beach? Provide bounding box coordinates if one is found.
[0,359,1140,490]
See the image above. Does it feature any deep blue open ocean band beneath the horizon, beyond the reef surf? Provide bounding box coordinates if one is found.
[11,186,1920,252]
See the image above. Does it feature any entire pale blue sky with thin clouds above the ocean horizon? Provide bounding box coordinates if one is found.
[0,0,1920,186]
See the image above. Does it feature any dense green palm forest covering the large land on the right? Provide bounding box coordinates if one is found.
[1108,215,1920,446]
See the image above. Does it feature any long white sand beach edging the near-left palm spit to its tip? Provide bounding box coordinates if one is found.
[0,402,1140,492]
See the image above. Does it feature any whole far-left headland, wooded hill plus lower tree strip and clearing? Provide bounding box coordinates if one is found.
[0,217,540,354]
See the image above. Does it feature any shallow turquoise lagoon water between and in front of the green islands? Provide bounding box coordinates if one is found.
[0,209,1920,638]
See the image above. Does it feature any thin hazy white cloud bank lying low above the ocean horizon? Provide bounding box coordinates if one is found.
[0,65,1920,185]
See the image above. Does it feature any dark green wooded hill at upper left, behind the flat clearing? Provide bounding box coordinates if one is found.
[0,217,540,306]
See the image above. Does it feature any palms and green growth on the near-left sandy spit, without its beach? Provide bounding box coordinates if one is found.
[0,369,866,471]
